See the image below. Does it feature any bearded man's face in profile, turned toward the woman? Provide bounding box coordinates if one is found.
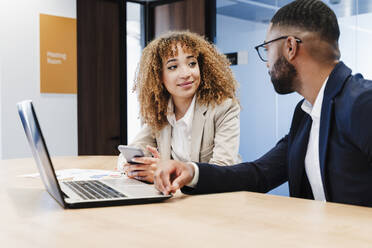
[266,24,297,94]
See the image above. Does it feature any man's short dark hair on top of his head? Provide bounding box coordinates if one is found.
[271,0,340,44]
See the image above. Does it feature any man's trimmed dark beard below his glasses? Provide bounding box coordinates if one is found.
[269,55,297,95]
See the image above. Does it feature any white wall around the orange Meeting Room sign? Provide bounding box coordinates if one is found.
[0,0,77,159]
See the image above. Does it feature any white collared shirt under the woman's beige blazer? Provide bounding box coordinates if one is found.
[167,95,196,162]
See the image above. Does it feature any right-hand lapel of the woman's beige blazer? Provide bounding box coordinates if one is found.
[190,102,208,162]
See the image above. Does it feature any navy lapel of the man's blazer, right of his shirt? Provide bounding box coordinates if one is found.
[319,62,351,200]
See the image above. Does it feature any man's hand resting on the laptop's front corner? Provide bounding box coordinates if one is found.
[154,160,195,195]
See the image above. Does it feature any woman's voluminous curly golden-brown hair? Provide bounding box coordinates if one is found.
[133,31,238,132]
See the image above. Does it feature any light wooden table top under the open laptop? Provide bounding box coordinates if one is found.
[0,156,372,248]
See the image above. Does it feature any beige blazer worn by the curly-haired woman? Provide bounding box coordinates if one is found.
[129,99,241,165]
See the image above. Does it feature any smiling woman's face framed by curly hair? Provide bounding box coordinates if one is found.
[162,44,200,101]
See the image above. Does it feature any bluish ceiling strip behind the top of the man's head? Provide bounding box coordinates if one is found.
[217,0,372,23]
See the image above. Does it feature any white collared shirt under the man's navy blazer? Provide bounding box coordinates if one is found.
[301,77,328,201]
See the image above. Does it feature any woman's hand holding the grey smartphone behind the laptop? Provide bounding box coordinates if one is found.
[124,146,160,183]
